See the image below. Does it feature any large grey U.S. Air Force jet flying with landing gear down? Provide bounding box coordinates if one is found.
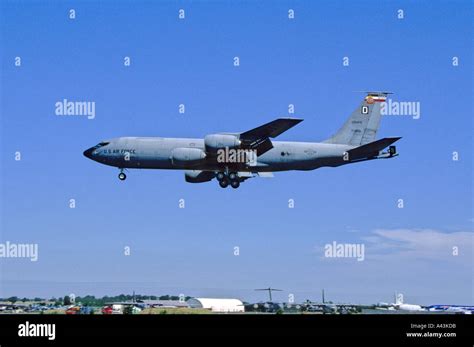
[84,92,401,188]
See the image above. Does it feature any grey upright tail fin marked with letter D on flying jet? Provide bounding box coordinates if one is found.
[324,92,391,146]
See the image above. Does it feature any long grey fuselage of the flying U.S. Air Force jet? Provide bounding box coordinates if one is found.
[84,137,354,172]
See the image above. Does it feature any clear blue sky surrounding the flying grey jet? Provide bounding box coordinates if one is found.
[0,1,474,304]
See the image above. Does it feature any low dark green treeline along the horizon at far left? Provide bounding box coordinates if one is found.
[0,294,190,306]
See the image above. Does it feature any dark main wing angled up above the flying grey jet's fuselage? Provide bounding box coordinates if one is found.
[239,118,303,155]
